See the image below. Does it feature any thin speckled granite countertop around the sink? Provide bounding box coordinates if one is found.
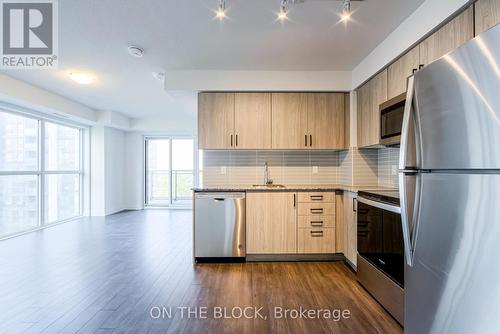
[192,184,397,192]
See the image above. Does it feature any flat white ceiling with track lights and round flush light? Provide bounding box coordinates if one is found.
[3,0,424,118]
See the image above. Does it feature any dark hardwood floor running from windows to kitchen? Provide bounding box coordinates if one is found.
[0,210,402,334]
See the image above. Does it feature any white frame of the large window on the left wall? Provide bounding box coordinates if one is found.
[0,104,85,239]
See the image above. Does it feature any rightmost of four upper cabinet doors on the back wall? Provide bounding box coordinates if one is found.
[307,93,344,149]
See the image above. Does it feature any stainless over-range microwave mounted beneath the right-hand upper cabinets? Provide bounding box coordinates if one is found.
[380,93,406,146]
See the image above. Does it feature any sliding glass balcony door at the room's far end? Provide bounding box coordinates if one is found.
[145,137,195,207]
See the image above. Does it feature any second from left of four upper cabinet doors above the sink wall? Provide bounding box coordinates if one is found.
[234,93,271,149]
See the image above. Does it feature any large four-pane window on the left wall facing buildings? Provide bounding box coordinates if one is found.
[0,110,82,237]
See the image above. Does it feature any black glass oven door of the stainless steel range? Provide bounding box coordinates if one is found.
[357,196,404,288]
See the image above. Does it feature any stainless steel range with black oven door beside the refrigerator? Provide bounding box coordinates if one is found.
[357,191,404,324]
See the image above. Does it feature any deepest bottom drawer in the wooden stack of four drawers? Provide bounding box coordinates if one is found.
[298,228,335,254]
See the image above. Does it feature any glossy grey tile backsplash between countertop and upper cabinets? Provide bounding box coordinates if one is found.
[202,148,399,188]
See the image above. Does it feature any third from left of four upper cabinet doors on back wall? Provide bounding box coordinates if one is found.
[271,93,308,149]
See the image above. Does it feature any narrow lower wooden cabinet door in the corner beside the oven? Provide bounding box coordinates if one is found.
[339,192,358,266]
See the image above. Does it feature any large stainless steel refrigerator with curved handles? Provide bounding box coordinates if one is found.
[399,25,500,334]
